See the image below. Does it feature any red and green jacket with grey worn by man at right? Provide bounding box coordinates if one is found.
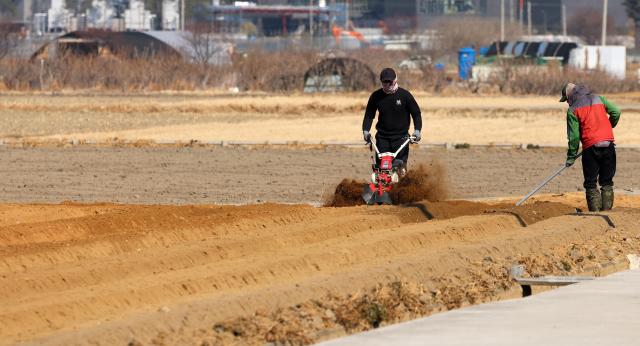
[567,86,620,159]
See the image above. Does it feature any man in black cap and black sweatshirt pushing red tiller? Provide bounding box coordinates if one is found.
[362,68,422,176]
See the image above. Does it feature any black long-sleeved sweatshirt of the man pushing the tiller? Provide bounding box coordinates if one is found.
[362,88,422,137]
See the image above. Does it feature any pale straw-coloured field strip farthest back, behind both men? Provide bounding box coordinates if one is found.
[0,93,640,146]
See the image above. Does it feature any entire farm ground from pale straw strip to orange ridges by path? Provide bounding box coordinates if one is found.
[0,93,640,346]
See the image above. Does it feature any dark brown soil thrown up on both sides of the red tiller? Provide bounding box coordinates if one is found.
[324,161,447,207]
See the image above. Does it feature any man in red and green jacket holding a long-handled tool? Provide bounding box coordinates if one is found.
[560,83,620,211]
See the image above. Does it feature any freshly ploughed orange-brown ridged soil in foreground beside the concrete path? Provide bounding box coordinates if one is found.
[0,195,640,345]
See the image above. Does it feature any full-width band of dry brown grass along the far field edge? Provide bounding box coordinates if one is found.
[0,45,640,95]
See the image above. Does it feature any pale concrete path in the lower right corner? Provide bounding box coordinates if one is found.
[320,269,640,346]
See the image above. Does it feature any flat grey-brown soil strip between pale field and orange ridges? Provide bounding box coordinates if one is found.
[0,146,640,205]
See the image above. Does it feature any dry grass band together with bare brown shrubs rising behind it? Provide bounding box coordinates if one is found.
[0,17,640,95]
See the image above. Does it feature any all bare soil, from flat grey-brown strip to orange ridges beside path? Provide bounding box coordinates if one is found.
[0,146,640,345]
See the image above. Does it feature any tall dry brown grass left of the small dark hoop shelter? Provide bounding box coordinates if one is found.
[0,51,314,92]
